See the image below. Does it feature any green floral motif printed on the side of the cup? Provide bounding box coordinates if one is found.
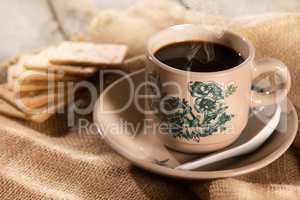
[146,71,237,142]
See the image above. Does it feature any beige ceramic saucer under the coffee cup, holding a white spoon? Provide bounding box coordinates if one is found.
[94,70,298,179]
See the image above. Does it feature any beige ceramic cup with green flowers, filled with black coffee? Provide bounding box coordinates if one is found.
[146,24,291,153]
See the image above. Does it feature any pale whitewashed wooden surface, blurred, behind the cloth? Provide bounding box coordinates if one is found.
[0,0,300,60]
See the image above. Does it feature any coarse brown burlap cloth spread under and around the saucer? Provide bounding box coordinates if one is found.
[0,15,300,200]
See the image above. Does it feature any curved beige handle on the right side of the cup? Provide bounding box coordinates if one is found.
[251,58,291,107]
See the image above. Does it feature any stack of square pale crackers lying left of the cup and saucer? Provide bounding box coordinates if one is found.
[0,42,127,123]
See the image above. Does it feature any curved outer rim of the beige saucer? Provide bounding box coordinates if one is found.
[93,69,298,180]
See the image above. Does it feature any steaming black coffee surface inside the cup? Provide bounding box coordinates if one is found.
[154,41,244,72]
